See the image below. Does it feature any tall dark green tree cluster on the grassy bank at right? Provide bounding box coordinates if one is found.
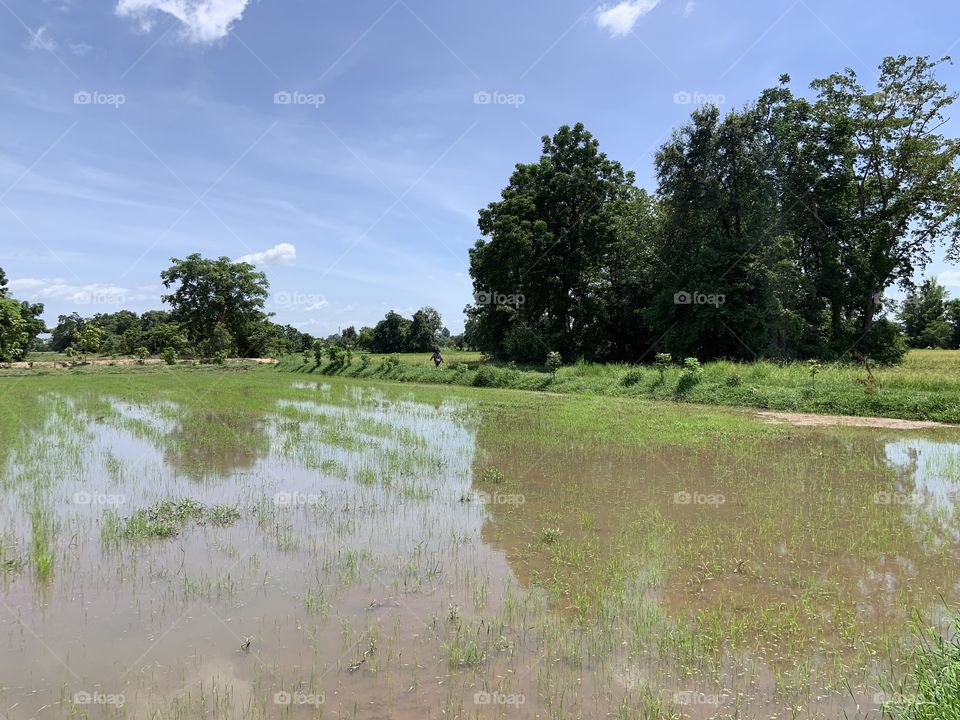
[466,56,960,362]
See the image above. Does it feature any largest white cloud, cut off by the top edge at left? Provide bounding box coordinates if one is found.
[116,0,249,44]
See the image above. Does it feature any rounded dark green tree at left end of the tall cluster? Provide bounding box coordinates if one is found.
[469,123,635,360]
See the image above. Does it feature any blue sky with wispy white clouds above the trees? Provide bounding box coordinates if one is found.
[0,0,960,335]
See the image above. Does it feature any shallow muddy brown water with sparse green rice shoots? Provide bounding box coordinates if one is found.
[0,383,960,719]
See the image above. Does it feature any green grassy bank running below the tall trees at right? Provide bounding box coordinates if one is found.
[268,350,960,423]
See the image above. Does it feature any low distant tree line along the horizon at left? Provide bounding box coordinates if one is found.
[0,253,463,362]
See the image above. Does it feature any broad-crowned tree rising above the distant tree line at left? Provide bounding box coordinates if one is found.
[160,253,270,357]
